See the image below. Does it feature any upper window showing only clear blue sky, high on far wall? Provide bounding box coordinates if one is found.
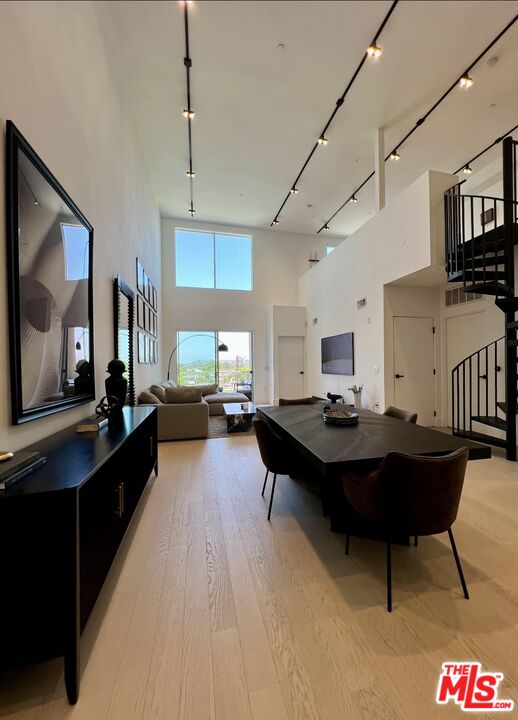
[175,228,252,291]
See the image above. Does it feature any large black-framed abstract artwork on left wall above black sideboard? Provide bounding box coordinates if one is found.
[6,120,95,424]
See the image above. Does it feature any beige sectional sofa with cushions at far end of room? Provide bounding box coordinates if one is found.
[139,380,248,441]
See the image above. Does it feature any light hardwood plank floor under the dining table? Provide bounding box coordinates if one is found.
[0,436,518,720]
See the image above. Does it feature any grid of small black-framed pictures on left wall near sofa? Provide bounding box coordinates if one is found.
[136,258,158,365]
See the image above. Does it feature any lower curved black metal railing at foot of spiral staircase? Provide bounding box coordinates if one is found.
[451,336,506,434]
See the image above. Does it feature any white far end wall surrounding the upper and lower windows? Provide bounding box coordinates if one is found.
[162,218,328,402]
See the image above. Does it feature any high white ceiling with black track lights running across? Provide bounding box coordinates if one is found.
[96,0,518,236]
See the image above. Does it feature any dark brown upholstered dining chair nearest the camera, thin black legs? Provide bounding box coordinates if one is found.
[343,448,469,612]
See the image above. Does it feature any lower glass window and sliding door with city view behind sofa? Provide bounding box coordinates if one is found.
[177,330,252,392]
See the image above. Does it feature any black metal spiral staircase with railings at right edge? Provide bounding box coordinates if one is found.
[444,137,518,460]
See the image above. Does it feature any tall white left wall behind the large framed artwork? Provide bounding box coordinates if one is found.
[0,2,161,449]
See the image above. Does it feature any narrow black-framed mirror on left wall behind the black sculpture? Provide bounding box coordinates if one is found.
[113,275,135,405]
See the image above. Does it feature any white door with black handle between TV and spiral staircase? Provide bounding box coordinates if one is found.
[394,317,435,425]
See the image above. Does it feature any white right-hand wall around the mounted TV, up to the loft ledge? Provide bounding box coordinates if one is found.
[298,166,456,408]
